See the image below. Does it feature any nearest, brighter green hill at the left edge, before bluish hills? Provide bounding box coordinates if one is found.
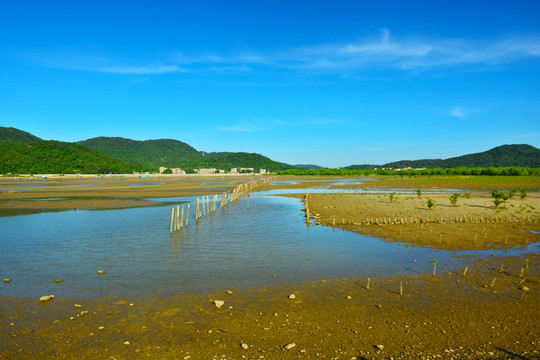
[0,140,141,174]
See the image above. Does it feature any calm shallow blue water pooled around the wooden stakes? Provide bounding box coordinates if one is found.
[0,195,538,297]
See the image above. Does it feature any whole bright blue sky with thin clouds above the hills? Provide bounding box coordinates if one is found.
[0,0,540,167]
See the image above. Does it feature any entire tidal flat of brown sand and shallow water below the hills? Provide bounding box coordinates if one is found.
[0,177,540,359]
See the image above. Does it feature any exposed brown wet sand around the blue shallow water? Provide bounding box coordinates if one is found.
[0,174,540,360]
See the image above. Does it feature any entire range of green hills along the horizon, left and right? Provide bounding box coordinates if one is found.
[0,127,540,174]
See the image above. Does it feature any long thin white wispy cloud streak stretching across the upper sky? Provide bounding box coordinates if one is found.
[29,29,540,77]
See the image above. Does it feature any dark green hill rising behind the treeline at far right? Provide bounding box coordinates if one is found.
[382,144,540,169]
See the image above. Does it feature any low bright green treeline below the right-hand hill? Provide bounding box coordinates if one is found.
[278,166,540,176]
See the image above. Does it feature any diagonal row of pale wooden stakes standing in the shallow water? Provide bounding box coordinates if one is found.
[170,177,275,234]
